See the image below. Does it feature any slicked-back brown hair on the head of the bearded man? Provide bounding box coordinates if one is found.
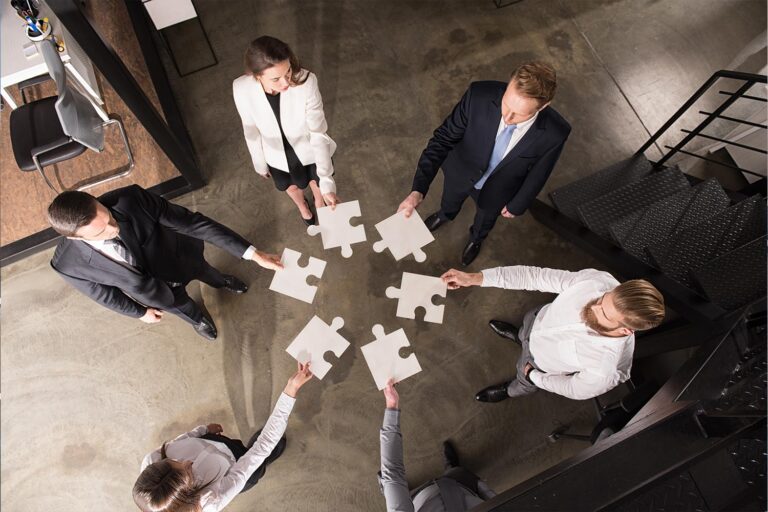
[611,279,664,331]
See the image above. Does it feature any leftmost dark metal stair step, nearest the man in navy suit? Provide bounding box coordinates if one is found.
[549,155,651,222]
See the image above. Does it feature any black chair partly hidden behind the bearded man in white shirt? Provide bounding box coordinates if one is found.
[547,381,659,444]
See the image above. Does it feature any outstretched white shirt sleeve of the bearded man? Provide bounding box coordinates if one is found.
[481,265,610,293]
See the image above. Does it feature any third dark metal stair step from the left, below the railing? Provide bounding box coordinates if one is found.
[608,178,730,263]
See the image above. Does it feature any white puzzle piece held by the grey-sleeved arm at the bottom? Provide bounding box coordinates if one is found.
[360,324,421,390]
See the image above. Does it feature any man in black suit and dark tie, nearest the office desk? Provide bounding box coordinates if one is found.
[48,185,282,340]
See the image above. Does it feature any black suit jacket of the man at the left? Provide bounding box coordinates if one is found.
[51,185,251,318]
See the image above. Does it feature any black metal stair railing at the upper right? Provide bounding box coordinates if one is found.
[637,70,768,177]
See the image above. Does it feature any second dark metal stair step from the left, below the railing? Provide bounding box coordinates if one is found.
[577,168,691,239]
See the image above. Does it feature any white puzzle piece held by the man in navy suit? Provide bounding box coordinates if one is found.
[373,210,435,263]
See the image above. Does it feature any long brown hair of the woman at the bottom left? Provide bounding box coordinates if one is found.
[133,444,205,512]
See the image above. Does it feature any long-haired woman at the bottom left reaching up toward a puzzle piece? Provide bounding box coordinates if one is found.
[133,363,312,512]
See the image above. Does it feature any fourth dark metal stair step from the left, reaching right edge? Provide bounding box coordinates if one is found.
[647,195,766,289]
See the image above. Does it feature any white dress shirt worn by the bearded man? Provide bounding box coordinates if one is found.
[482,265,635,400]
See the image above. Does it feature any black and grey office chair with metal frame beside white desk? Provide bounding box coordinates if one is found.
[10,39,134,193]
